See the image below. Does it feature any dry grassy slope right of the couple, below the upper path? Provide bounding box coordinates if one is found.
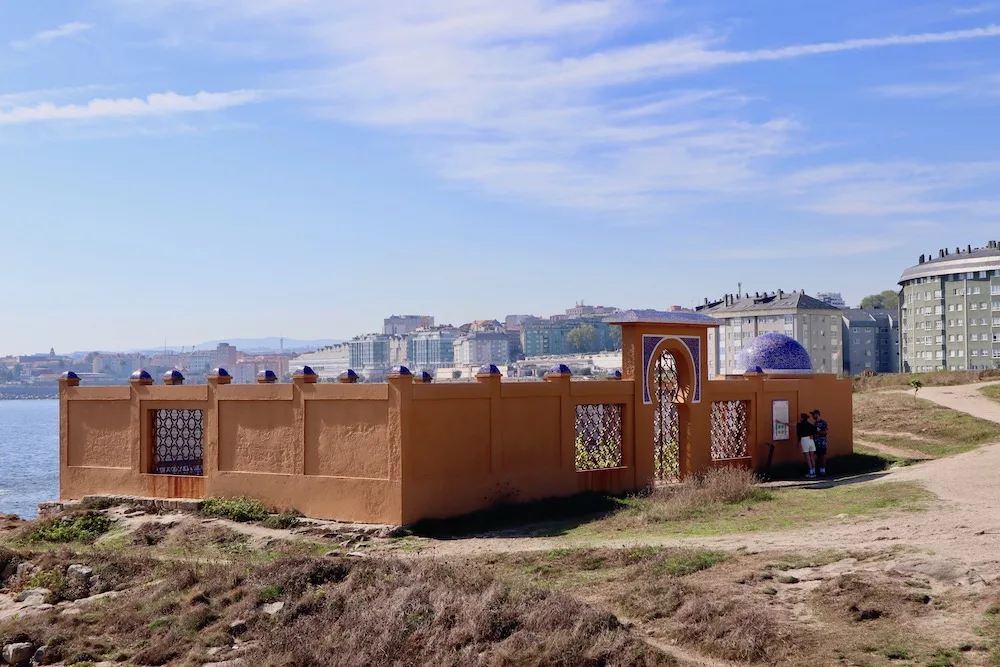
[854,392,1000,456]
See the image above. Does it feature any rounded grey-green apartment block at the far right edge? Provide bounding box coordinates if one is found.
[899,241,1000,372]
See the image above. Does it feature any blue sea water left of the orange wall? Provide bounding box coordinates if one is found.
[0,401,59,519]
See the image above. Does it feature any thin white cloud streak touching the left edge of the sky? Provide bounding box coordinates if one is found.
[0,90,262,125]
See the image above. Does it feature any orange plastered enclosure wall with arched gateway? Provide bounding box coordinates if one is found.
[60,324,853,524]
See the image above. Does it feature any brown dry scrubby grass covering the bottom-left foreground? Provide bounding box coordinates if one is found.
[0,552,674,667]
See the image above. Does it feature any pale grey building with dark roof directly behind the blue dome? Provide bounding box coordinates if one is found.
[696,290,844,378]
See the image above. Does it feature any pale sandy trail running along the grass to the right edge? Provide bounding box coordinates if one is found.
[413,384,1000,585]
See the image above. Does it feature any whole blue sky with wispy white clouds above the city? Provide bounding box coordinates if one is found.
[0,0,1000,354]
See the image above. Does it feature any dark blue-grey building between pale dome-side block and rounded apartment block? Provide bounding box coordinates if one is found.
[842,309,899,375]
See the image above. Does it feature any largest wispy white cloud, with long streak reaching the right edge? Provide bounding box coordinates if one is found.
[101,0,1000,219]
